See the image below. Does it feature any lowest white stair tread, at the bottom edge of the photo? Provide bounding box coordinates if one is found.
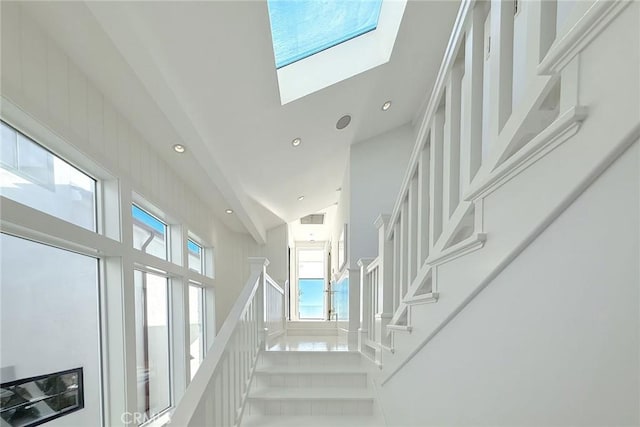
[241,415,386,427]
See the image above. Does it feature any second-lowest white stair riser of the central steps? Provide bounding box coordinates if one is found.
[253,373,367,388]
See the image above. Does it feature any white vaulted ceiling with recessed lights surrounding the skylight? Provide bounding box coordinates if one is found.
[21,0,459,241]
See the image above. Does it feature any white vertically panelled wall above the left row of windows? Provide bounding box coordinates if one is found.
[1,2,262,332]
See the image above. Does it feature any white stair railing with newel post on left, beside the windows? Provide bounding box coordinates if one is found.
[171,258,285,427]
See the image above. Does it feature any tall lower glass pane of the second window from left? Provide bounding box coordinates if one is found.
[134,270,171,419]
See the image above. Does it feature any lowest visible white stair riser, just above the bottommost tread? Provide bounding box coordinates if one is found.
[247,399,373,415]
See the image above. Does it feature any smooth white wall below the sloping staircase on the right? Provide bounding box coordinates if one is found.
[381,142,640,426]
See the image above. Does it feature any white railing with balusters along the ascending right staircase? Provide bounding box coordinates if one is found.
[360,0,629,363]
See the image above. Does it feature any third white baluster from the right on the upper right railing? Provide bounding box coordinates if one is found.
[460,4,485,194]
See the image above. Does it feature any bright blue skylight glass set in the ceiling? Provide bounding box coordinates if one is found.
[267,0,382,68]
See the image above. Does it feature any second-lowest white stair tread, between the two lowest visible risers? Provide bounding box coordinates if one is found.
[249,387,374,400]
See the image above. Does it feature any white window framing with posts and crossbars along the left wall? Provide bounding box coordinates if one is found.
[0,104,216,426]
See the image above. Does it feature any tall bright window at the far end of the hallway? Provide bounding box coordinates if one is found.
[298,249,325,319]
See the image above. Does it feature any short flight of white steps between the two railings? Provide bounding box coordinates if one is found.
[241,350,385,427]
